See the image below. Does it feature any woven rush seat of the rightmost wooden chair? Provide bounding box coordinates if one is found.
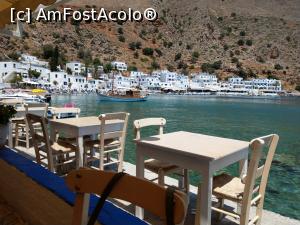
[212,174,245,202]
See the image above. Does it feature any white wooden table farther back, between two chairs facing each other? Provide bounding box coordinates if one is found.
[49,116,124,168]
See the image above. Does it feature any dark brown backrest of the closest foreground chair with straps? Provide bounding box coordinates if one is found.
[66,169,187,225]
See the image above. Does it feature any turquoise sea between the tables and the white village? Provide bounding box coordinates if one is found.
[52,95,300,219]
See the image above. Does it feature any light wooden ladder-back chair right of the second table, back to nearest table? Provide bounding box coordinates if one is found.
[83,112,130,172]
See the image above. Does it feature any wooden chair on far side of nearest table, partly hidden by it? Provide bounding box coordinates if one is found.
[133,118,189,193]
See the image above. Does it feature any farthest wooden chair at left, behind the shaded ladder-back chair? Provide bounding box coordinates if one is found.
[12,103,48,149]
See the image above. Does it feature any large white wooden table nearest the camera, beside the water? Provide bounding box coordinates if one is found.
[136,131,249,225]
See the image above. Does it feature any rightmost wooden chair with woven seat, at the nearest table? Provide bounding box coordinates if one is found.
[212,134,279,225]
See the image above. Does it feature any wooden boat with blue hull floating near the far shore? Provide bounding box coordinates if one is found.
[98,89,147,102]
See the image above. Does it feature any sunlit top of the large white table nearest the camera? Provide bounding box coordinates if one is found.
[136,131,249,161]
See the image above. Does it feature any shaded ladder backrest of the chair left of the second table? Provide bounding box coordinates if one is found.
[26,113,54,171]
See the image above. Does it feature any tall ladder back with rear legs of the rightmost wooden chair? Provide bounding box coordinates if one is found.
[241,134,279,221]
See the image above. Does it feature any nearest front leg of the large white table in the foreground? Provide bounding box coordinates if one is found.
[195,170,213,225]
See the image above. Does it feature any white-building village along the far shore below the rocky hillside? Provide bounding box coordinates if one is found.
[0,54,287,96]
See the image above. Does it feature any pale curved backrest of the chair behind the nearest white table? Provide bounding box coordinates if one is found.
[133,118,166,140]
